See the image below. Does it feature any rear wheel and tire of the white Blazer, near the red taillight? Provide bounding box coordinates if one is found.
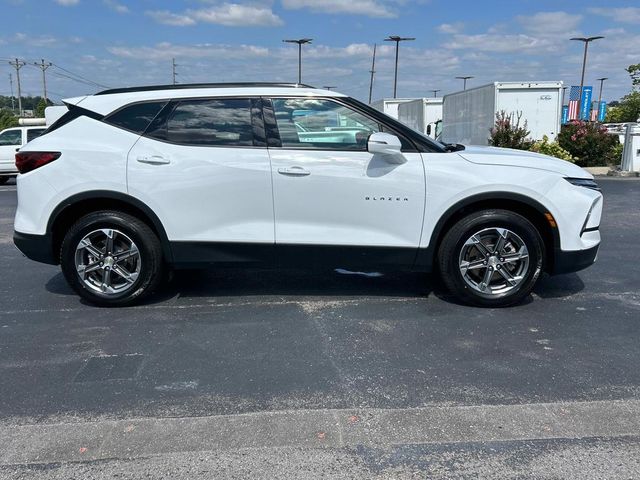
[60,211,164,307]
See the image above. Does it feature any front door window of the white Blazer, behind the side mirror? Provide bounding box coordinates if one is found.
[273,98,381,151]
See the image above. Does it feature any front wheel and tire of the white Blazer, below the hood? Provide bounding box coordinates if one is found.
[438,209,545,307]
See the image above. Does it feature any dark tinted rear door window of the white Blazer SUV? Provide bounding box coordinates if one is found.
[151,98,254,147]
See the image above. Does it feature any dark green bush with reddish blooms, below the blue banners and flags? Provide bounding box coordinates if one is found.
[558,120,620,167]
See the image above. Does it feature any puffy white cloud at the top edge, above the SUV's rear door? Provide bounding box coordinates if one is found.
[146,3,284,27]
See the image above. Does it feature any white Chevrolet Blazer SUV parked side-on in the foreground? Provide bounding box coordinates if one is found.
[14,84,602,306]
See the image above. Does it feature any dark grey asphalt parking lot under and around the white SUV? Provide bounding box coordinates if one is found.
[0,178,640,479]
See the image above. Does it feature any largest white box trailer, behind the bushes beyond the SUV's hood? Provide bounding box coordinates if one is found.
[441,82,562,145]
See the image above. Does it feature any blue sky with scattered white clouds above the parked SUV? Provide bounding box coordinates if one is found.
[0,0,640,101]
